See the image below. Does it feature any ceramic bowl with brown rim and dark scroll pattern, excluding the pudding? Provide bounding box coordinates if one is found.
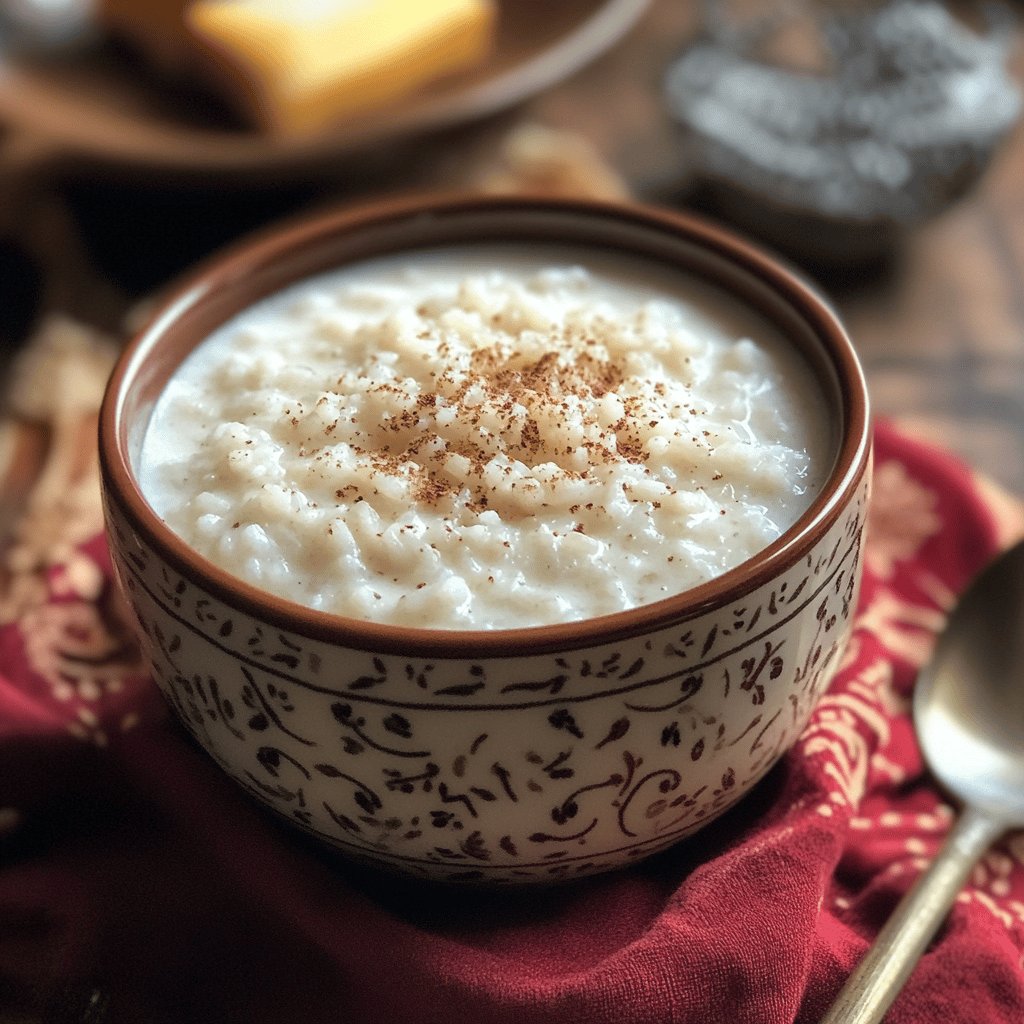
[99,198,870,883]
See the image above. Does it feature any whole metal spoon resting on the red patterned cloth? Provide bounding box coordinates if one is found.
[821,541,1024,1024]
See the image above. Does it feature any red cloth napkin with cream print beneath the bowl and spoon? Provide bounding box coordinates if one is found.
[0,417,1024,1024]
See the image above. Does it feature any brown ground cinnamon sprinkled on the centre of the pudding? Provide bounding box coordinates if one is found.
[317,329,665,512]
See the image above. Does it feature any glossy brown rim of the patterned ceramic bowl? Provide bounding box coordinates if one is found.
[99,196,870,658]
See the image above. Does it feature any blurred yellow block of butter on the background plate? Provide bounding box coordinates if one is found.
[185,0,497,133]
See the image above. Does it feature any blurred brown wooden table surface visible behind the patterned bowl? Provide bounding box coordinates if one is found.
[6,0,1024,507]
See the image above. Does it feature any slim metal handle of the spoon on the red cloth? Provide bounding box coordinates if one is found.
[821,807,1007,1024]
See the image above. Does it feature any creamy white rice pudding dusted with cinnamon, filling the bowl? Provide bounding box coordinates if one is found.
[138,244,834,630]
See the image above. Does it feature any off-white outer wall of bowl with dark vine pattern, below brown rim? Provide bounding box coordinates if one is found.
[109,483,866,882]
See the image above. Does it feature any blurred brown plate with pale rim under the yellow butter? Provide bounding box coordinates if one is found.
[0,0,647,176]
